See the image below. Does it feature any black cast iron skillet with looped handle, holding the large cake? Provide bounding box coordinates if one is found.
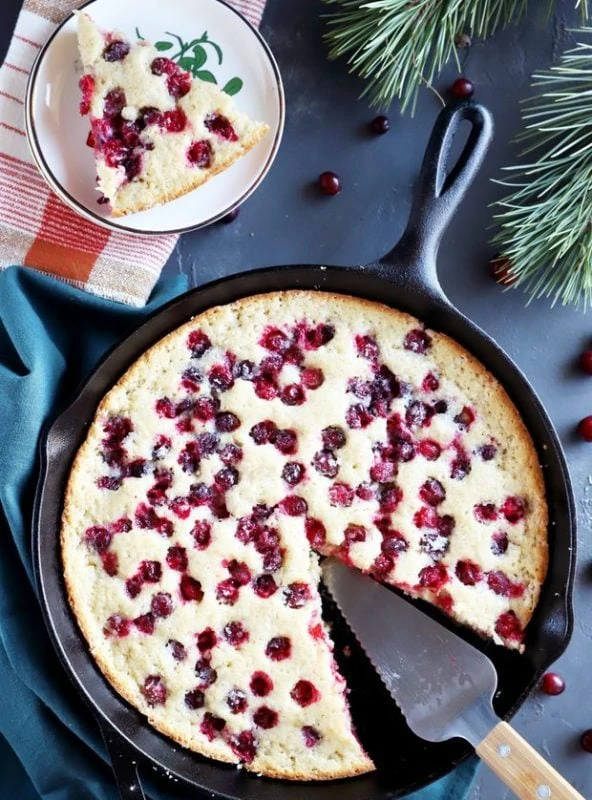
[33,103,576,800]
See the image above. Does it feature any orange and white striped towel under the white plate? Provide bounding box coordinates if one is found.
[0,0,265,306]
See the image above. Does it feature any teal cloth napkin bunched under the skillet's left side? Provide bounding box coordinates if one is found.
[0,267,478,800]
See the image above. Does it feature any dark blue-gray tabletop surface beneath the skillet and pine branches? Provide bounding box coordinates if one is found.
[0,0,592,800]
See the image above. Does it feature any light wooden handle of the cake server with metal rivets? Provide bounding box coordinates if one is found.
[477,722,585,800]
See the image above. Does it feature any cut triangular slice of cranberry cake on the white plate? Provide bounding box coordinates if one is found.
[78,13,269,217]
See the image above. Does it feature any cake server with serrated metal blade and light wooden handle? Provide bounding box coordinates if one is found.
[323,559,584,800]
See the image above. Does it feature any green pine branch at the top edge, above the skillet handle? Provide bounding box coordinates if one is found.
[324,0,588,111]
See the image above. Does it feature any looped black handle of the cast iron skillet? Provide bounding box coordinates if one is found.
[379,101,493,299]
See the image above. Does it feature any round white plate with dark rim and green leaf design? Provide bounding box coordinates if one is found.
[25,0,284,234]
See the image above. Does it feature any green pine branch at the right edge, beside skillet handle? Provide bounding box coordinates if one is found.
[494,27,592,309]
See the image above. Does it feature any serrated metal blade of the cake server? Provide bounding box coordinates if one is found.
[323,559,499,746]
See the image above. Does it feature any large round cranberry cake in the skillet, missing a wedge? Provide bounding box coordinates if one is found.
[61,291,547,779]
